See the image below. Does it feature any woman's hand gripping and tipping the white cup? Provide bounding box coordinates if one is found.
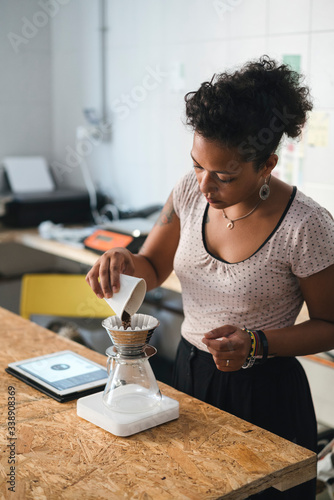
[86,247,135,299]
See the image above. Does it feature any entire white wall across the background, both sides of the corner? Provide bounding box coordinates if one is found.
[0,0,334,213]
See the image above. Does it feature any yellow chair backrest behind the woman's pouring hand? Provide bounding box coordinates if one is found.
[20,274,114,319]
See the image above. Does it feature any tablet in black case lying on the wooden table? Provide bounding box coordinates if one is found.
[6,351,108,402]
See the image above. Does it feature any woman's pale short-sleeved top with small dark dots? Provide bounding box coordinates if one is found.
[173,171,334,350]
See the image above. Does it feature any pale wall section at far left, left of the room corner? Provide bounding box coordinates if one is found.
[0,0,52,164]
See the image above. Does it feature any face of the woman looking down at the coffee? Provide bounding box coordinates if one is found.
[191,132,271,210]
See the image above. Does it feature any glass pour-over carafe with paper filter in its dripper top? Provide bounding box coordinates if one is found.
[102,314,161,414]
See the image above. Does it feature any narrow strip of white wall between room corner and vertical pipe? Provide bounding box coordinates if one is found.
[51,0,102,193]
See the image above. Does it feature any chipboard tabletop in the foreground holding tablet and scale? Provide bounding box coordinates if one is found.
[0,308,316,500]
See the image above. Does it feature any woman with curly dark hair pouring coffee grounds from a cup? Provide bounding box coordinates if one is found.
[87,56,334,500]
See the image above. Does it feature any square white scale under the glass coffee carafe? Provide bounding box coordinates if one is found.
[77,392,179,436]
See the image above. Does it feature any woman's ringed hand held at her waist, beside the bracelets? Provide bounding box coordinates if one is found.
[202,325,251,372]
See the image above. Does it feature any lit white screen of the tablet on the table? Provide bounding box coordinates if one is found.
[16,352,108,391]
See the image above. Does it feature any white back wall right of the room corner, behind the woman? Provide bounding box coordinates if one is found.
[52,0,334,212]
